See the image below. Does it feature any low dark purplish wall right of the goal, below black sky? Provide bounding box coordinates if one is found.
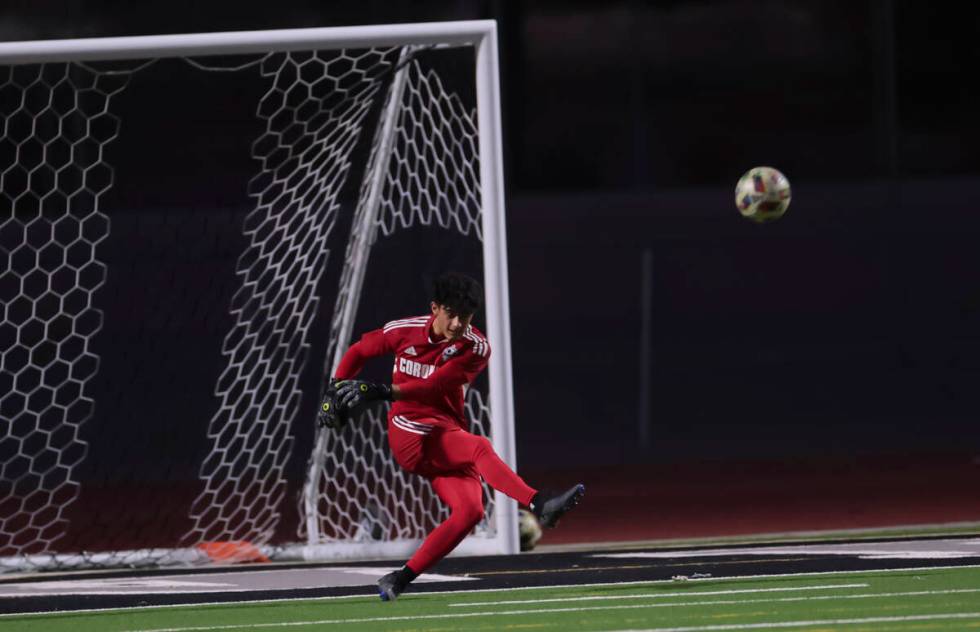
[509,178,980,466]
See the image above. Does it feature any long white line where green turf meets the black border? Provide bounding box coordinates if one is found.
[0,564,980,621]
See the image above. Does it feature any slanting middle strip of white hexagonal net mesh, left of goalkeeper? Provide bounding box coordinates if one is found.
[185,50,398,544]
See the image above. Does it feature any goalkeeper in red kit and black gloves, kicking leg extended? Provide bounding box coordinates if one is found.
[320,273,585,601]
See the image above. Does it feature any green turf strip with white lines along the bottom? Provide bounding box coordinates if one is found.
[7,567,980,632]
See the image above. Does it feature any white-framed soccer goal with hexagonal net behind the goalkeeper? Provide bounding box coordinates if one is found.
[0,22,517,570]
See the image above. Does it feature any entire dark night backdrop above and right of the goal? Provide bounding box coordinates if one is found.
[0,0,980,478]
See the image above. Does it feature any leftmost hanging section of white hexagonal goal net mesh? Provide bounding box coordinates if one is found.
[0,64,125,555]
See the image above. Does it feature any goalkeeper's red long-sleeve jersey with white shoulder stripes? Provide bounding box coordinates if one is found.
[335,315,490,430]
